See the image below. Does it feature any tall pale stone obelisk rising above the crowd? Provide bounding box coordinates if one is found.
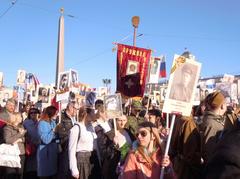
[55,8,64,87]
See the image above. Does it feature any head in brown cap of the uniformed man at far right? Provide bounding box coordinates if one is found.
[205,91,227,115]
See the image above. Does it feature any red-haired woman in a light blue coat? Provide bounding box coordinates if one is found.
[37,106,58,179]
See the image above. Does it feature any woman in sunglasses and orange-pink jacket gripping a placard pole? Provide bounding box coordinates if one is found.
[122,121,176,179]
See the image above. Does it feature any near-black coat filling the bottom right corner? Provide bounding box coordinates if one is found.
[203,128,240,179]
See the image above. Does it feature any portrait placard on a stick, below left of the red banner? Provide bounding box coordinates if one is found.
[103,93,123,119]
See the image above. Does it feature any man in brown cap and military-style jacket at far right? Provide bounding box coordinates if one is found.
[201,91,227,164]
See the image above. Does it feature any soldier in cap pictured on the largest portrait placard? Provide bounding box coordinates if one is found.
[169,64,193,102]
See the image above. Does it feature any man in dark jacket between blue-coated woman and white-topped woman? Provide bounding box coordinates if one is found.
[56,101,78,179]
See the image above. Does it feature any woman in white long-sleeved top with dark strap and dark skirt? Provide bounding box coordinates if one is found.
[68,107,101,179]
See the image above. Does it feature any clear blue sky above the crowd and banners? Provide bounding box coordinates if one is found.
[0,0,240,89]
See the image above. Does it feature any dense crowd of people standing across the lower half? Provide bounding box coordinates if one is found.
[0,91,240,179]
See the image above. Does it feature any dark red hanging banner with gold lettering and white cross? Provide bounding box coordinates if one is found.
[117,44,151,97]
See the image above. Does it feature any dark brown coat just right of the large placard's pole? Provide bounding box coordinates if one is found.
[170,117,202,179]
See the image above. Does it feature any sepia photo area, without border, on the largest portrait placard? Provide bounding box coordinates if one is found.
[169,63,197,102]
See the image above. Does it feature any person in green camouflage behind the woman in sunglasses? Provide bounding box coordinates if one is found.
[126,100,144,134]
